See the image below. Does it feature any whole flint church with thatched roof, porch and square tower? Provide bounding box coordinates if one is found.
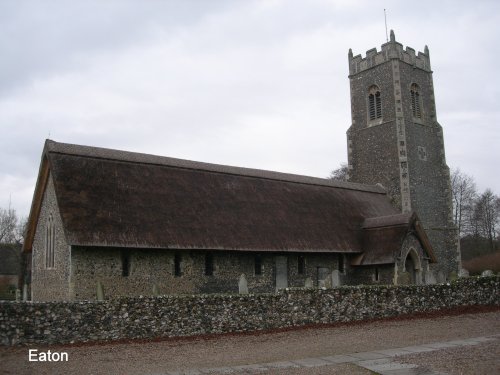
[24,31,459,301]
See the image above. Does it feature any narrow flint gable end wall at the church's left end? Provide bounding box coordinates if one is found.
[31,175,70,301]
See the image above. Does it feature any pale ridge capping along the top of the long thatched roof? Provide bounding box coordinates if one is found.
[43,139,386,194]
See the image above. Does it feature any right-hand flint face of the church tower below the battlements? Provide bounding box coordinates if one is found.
[400,60,460,281]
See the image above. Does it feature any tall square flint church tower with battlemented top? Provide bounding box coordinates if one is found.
[347,30,460,282]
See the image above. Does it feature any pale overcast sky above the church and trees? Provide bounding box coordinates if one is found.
[0,0,500,216]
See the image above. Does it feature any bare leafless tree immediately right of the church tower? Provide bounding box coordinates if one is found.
[451,168,477,236]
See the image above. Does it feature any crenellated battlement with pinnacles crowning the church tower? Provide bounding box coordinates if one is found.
[349,30,431,75]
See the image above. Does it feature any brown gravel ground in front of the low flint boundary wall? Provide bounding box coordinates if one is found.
[0,310,500,375]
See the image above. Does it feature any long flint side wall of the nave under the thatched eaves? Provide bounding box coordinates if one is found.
[71,246,344,300]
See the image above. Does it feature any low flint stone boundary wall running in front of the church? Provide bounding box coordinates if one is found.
[0,276,500,345]
